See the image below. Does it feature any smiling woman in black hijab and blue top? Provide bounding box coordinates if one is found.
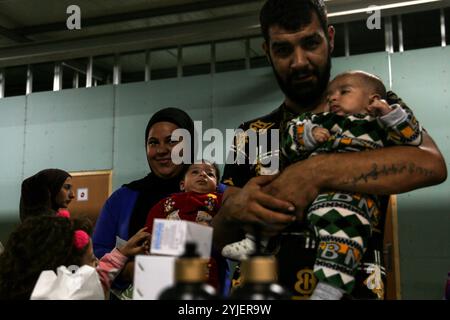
[92,108,194,296]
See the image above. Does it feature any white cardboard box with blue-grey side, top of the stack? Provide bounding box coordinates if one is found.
[150,219,213,259]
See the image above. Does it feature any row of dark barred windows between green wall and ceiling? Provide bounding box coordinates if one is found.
[0,7,450,98]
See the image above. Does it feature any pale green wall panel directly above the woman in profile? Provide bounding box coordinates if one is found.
[24,86,114,176]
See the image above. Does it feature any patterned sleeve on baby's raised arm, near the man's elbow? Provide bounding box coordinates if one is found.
[379,104,422,146]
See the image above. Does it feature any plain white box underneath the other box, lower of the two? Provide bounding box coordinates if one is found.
[133,255,176,300]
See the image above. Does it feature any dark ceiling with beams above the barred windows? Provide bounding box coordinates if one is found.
[0,0,450,67]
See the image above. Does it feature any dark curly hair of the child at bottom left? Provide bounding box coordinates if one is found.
[0,216,92,300]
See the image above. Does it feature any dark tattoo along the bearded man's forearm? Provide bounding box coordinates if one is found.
[345,163,434,186]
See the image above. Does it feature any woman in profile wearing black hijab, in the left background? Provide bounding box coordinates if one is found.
[20,169,75,221]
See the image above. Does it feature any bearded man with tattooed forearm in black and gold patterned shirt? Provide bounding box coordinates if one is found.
[213,0,447,299]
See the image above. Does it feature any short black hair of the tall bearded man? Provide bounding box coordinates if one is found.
[259,0,328,43]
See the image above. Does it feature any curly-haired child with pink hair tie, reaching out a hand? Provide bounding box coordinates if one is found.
[0,215,150,300]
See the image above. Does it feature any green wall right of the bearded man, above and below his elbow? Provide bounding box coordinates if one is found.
[392,47,450,299]
